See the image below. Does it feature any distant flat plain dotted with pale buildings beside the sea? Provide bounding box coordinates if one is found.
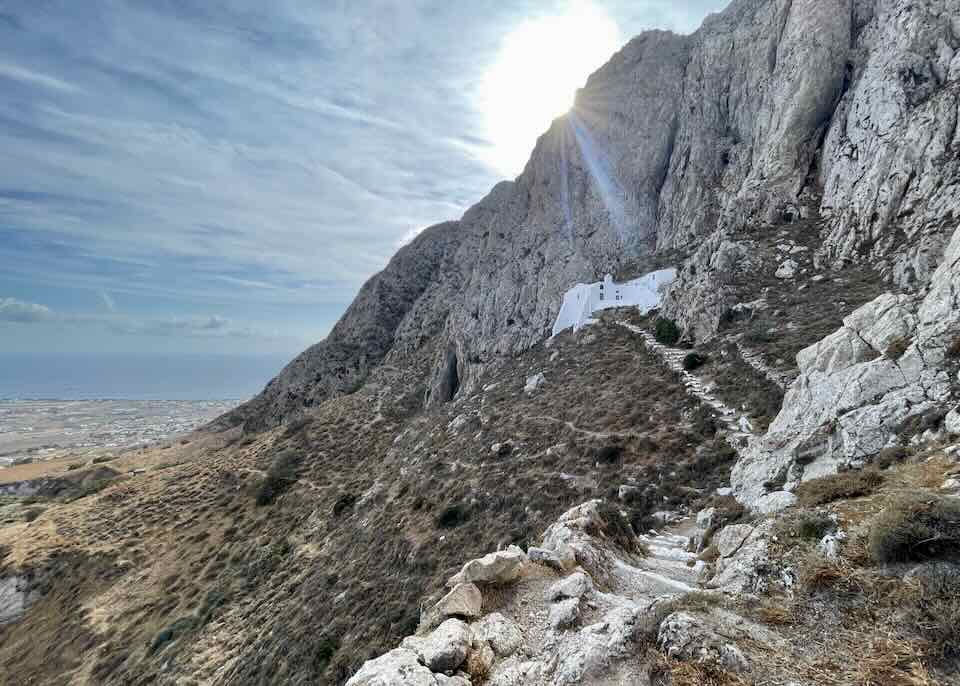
[0,400,239,468]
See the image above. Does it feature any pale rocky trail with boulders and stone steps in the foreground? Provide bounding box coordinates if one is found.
[349,501,704,686]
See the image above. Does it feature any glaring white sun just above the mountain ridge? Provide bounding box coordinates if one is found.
[480,0,622,177]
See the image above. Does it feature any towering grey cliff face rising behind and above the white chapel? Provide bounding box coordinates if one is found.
[220,0,960,429]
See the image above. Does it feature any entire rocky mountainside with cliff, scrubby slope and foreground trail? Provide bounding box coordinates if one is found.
[0,0,960,686]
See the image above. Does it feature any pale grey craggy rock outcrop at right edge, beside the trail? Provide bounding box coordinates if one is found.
[731,223,960,509]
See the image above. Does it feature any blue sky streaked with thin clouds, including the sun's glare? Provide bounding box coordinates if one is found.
[0,0,726,355]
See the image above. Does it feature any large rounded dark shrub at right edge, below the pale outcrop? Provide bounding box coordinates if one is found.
[867,494,960,562]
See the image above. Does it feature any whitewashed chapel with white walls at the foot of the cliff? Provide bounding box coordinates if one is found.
[553,268,677,336]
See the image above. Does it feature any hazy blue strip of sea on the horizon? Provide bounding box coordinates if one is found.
[0,353,290,400]
